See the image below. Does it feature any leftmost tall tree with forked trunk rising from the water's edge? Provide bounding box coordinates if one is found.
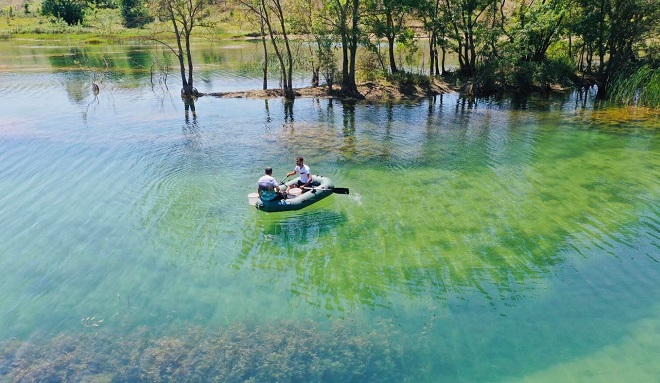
[151,0,208,98]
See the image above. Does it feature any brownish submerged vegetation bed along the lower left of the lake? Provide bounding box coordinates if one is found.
[0,321,407,383]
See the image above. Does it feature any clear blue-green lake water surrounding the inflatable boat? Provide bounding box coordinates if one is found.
[0,40,660,382]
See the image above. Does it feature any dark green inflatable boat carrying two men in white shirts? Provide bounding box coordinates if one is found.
[255,174,336,212]
